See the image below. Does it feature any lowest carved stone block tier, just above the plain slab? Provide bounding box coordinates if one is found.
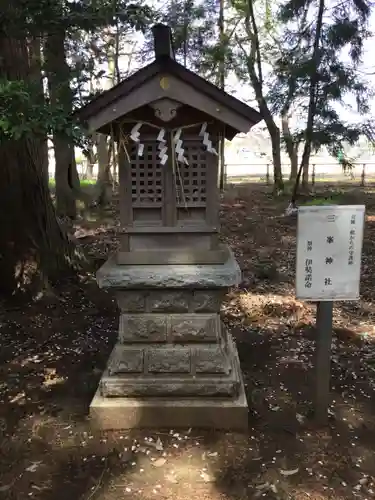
[99,338,240,398]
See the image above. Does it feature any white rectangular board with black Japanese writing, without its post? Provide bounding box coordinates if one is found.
[296,205,365,301]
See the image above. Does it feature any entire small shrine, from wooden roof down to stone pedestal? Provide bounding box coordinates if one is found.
[78,25,262,428]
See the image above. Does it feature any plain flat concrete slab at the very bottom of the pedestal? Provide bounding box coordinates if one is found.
[90,374,248,432]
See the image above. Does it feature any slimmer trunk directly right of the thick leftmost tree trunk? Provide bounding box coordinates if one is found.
[45,30,81,219]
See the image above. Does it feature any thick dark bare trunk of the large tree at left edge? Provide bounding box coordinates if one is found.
[0,35,71,296]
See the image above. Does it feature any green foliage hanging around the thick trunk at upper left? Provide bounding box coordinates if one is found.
[0,0,153,147]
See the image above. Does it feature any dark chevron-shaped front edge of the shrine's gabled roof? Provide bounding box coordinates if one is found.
[74,58,263,129]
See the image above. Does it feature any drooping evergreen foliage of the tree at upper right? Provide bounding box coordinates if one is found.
[267,0,374,162]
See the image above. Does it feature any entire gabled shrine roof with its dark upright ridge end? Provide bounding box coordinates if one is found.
[75,24,262,138]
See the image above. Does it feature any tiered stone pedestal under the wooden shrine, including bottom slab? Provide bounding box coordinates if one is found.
[90,248,248,430]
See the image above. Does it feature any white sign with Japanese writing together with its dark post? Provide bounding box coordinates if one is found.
[296,205,365,424]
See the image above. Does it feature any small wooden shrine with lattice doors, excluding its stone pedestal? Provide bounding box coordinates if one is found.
[80,25,261,264]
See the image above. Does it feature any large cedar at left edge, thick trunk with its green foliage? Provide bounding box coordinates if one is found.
[0,0,153,295]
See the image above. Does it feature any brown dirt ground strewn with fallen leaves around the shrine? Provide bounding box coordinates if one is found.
[0,186,375,500]
